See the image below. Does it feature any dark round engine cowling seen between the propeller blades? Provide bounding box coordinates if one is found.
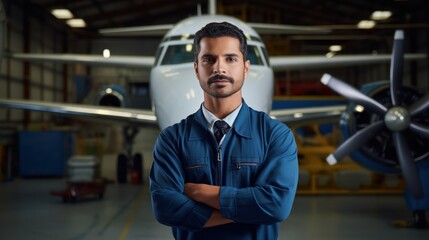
[340,81,429,173]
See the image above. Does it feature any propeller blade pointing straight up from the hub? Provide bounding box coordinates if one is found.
[390,30,404,106]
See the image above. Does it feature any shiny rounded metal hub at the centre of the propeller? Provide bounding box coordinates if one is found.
[384,107,411,132]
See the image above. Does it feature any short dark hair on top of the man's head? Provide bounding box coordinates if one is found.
[194,22,247,62]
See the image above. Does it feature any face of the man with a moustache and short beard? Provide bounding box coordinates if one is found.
[194,37,250,98]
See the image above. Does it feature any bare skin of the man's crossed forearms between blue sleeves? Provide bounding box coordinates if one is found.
[184,183,233,228]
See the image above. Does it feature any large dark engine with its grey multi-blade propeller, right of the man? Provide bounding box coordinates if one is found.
[321,31,429,228]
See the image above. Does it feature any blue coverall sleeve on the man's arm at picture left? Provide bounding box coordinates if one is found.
[150,132,213,231]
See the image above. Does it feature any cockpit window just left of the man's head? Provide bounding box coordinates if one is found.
[161,43,194,65]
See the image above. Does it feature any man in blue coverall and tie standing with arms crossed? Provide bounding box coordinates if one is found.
[150,22,298,240]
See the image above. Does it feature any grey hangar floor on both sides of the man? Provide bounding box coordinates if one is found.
[0,178,429,240]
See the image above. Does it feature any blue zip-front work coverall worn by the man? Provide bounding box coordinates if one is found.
[150,101,298,240]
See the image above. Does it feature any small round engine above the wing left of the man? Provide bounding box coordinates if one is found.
[95,85,128,108]
